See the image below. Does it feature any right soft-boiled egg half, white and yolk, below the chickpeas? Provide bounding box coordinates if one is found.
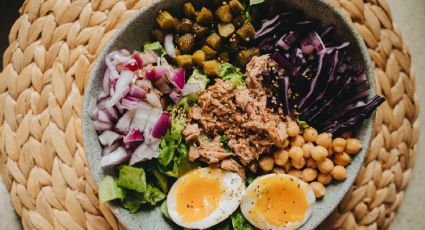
[241,174,316,230]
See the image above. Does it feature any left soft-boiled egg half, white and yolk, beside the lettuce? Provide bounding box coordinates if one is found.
[167,168,245,229]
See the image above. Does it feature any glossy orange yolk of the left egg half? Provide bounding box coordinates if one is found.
[176,173,223,223]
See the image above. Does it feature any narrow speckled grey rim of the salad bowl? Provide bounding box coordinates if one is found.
[82,0,376,229]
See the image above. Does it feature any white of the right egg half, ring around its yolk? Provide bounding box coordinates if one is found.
[241,174,316,230]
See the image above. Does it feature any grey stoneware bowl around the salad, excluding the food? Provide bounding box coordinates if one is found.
[83,0,375,230]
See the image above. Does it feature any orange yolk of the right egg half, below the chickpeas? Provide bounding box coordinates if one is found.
[249,177,309,226]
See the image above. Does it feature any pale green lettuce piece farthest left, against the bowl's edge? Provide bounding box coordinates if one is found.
[99,176,125,203]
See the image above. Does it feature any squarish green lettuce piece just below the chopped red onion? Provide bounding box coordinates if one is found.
[117,165,146,192]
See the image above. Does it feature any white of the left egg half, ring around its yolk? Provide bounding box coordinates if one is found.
[167,168,245,229]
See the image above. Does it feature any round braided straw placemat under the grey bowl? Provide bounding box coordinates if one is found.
[0,0,419,230]
